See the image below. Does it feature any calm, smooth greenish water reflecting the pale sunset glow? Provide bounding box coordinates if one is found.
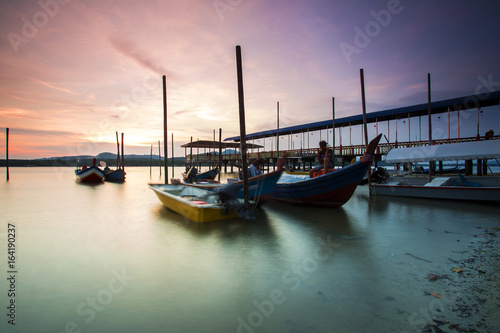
[0,168,500,333]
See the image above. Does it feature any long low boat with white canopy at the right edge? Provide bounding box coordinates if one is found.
[370,140,500,203]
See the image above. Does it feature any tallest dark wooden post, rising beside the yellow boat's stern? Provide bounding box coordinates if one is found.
[236,45,249,205]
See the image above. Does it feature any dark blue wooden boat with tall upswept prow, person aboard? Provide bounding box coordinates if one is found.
[271,134,382,207]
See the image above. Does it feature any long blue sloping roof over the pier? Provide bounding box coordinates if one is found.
[224,90,500,142]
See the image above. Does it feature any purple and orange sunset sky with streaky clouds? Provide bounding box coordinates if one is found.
[0,0,500,159]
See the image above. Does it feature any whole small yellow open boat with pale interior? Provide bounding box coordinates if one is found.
[149,184,238,222]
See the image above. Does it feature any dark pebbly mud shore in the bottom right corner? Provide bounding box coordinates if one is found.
[420,227,500,332]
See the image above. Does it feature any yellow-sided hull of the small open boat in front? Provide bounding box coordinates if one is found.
[150,185,238,222]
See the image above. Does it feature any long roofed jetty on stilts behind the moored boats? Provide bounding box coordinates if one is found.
[182,91,500,174]
